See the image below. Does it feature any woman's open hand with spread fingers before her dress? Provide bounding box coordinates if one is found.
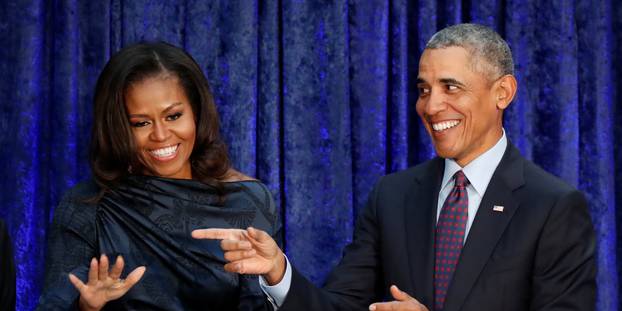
[69,255,146,311]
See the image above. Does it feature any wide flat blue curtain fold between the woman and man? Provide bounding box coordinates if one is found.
[281,1,352,282]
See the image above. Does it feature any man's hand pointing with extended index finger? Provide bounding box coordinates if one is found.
[192,227,285,285]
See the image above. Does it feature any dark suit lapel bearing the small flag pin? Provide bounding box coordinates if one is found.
[444,143,524,311]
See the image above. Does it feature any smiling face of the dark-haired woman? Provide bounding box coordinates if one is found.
[125,75,196,179]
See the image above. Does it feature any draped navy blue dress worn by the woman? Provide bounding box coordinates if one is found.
[38,176,280,310]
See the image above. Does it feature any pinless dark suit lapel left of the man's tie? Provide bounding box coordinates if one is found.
[404,158,444,306]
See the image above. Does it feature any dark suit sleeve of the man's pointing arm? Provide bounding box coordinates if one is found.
[279,180,382,311]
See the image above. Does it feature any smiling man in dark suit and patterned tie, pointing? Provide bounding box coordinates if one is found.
[193,24,596,311]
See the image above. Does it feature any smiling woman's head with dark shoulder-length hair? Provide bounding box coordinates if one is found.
[91,43,237,194]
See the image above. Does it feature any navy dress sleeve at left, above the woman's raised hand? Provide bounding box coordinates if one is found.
[37,187,97,310]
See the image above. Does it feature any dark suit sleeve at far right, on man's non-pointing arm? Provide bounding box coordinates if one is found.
[531,191,596,310]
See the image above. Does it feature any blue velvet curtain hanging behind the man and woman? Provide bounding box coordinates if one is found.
[0,0,622,310]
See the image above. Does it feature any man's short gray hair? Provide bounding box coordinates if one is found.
[425,24,514,80]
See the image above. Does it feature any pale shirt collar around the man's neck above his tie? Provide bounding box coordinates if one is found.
[441,129,508,196]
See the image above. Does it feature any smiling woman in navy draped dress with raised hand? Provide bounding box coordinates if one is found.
[39,43,279,310]
